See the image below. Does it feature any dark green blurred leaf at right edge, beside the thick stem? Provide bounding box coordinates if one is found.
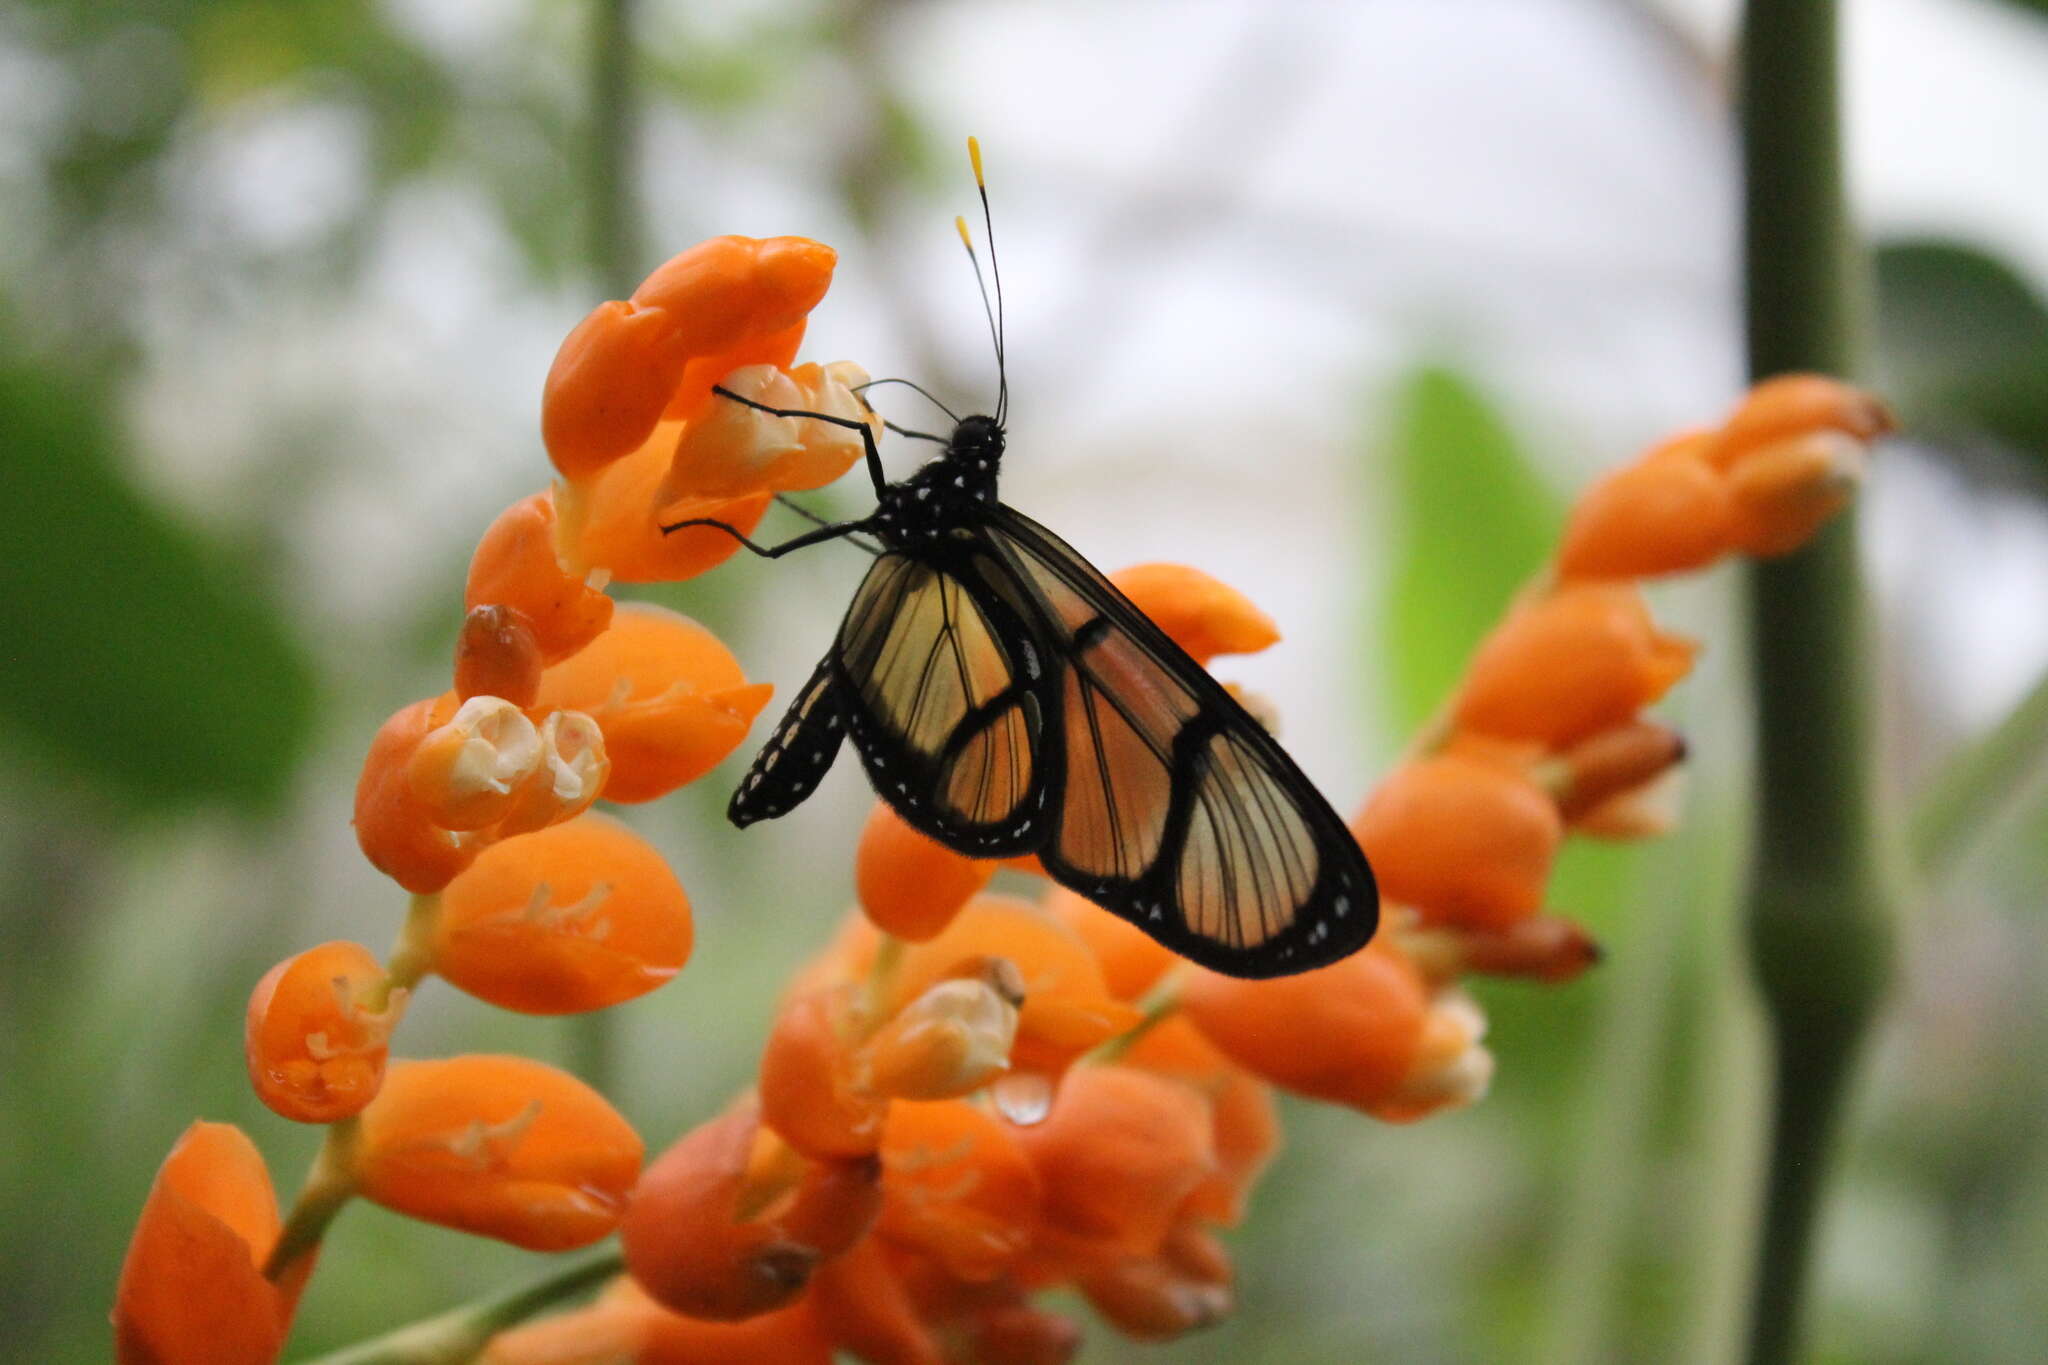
[1878,239,2048,487]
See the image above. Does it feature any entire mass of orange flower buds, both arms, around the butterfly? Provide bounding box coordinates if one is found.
[103,224,1886,1365]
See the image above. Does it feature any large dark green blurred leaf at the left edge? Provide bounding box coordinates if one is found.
[0,351,313,806]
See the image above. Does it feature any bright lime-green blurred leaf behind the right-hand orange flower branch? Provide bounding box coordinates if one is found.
[1380,366,1559,735]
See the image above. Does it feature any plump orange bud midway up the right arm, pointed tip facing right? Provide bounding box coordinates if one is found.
[1454,583,1694,747]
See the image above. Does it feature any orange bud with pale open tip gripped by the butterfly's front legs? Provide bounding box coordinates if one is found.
[655,362,881,510]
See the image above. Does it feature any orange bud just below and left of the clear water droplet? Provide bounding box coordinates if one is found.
[881,1099,1038,1281]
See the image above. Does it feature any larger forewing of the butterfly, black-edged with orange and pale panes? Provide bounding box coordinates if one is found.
[985,505,1378,976]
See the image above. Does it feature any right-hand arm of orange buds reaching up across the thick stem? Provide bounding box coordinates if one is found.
[1352,375,1890,980]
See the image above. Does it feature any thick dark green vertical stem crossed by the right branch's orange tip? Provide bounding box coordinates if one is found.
[1739,0,1892,1365]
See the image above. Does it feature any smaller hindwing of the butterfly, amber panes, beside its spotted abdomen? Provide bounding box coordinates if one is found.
[829,538,1059,857]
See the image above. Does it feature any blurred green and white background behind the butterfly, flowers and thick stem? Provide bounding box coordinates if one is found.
[0,0,2048,1365]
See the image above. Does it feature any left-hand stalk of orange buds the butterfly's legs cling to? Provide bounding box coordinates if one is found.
[115,237,880,1365]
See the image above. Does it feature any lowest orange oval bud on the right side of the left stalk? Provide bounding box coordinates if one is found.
[354,1056,641,1250]
